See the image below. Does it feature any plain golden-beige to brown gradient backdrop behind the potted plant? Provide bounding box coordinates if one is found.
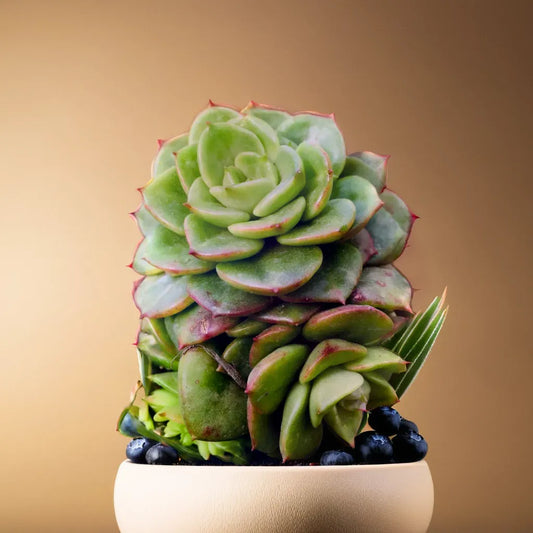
[0,0,533,532]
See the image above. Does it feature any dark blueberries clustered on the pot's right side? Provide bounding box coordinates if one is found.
[320,407,428,465]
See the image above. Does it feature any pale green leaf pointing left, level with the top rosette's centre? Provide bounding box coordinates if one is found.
[141,167,189,235]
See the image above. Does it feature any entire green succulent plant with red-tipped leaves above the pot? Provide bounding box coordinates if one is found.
[119,102,446,464]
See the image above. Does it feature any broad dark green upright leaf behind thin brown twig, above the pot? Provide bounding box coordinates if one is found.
[178,346,247,441]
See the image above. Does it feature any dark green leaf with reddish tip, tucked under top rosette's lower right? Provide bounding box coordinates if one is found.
[283,242,363,304]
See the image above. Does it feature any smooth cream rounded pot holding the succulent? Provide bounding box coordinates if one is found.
[115,461,433,533]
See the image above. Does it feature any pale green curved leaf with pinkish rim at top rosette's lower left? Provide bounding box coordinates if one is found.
[143,226,215,275]
